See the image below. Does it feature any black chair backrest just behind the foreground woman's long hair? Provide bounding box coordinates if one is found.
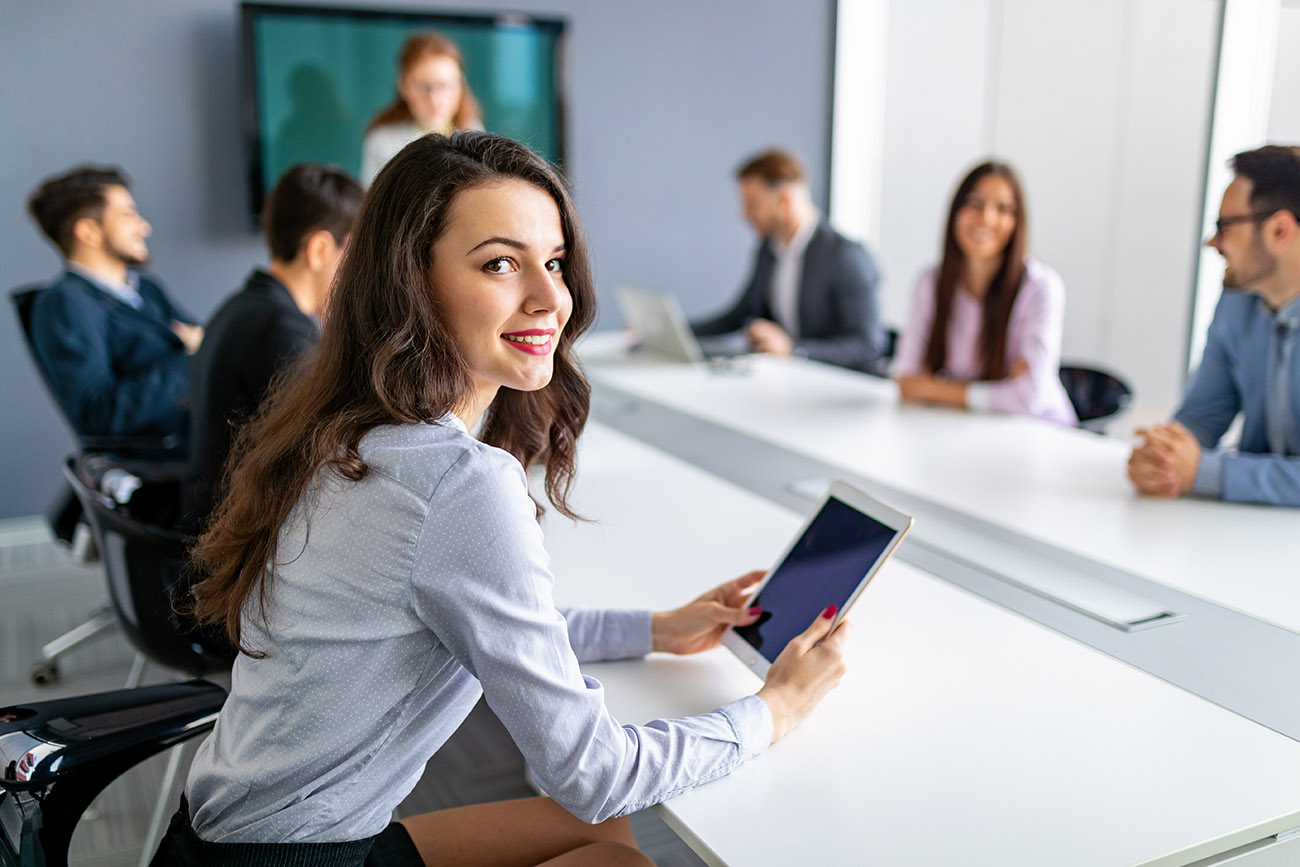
[64,456,234,675]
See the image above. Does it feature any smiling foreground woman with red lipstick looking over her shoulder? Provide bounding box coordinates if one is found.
[155,133,844,867]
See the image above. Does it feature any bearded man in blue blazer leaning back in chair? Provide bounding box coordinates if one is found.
[27,166,203,435]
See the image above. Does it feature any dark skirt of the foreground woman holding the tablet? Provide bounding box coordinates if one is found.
[150,796,424,867]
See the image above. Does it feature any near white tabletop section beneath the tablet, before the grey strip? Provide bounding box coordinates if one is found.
[543,422,1300,867]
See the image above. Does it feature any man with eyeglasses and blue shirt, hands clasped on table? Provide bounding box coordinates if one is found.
[1128,146,1300,506]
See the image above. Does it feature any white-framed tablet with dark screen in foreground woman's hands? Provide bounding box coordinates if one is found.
[723,482,911,677]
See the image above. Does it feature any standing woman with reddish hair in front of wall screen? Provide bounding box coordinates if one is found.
[360,30,484,186]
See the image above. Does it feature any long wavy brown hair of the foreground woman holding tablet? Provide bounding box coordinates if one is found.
[191,131,595,656]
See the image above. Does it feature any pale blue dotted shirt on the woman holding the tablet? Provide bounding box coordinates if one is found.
[186,416,772,842]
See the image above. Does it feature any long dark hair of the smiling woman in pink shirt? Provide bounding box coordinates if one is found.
[926,161,1030,380]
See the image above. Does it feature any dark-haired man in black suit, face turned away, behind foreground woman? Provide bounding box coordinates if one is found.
[185,164,363,529]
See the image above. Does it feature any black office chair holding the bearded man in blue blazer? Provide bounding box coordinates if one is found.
[9,285,187,686]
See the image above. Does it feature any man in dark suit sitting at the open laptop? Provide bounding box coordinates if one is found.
[692,149,885,373]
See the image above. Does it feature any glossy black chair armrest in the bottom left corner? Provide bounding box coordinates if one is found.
[0,680,226,867]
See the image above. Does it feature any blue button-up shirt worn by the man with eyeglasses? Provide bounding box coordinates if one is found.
[1174,290,1300,506]
